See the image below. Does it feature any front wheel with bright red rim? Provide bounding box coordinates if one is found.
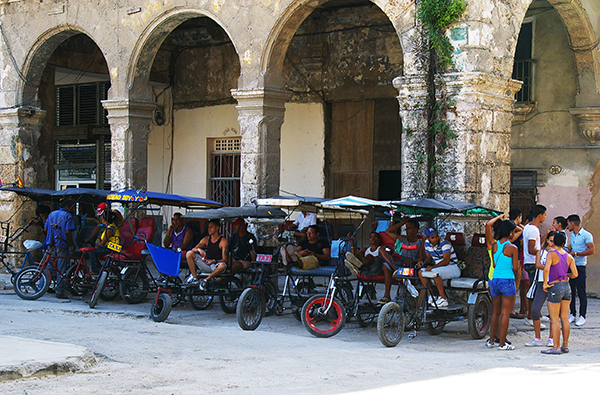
[301,295,346,337]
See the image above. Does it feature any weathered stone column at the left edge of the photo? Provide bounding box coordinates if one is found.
[0,107,48,234]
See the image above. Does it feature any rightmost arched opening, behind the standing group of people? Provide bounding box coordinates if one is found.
[511,0,600,229]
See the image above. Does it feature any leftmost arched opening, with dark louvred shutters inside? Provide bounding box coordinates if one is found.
[30,30,110,189]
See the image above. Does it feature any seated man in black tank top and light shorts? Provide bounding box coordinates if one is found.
[186,219,229,291]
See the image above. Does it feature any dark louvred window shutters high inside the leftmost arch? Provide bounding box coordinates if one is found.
[55,81,110,126]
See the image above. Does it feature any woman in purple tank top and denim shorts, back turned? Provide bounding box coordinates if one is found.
[542,233,578,355]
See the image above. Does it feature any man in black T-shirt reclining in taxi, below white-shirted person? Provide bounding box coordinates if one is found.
[281,225,331,270]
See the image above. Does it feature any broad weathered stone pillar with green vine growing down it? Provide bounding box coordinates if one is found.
[394,72,521,211]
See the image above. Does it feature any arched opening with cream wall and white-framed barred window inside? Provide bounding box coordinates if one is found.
[141,14,240,206]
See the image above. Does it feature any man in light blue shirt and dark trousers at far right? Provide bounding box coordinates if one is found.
[567,214,596,326]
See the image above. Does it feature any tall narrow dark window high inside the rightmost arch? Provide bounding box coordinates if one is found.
[512,22,534,103]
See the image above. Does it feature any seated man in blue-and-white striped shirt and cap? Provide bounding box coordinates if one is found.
[419,228,460,307]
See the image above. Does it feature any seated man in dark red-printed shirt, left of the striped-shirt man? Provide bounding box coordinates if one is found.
[379,217,425,304]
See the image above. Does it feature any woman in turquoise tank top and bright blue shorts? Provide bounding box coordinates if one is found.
[485,221,521,350]
